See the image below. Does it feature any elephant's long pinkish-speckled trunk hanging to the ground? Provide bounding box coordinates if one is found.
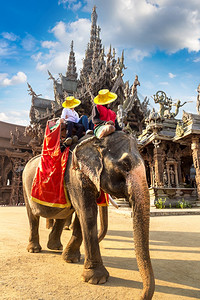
[127,162,155,299]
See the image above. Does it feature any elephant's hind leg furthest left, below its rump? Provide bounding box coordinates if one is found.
[26,203,42,253]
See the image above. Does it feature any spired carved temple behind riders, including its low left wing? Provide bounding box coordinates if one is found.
[0,7,149,205]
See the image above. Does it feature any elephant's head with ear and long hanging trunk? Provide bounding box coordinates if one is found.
[73,132,155,299]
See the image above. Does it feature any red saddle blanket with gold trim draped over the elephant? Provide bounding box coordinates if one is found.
[31,125,109,208]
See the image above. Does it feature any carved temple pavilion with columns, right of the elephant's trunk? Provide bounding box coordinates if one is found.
[138,91,200,207]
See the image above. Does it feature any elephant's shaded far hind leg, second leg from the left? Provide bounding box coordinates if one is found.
[47,219,65,250]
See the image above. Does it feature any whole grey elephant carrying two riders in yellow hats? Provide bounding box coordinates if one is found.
[23,131,155,299]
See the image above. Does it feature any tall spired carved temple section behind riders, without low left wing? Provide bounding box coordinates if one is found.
[26,7,149,154]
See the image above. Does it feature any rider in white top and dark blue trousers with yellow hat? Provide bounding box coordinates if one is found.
[60,96,93,146]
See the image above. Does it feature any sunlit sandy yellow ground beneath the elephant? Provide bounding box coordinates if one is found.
[0,207,200,300]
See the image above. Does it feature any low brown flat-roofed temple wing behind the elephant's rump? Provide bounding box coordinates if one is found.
[0,121,32,205]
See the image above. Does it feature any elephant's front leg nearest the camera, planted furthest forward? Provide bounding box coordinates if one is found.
[78,196,109,284]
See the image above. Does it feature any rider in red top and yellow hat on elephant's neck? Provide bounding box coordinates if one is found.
[92,89,122,138]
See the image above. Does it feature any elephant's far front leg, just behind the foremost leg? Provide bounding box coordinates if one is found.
[62,214,82,263]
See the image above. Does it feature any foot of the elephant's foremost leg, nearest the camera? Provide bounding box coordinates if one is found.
[81,265,109,284]
